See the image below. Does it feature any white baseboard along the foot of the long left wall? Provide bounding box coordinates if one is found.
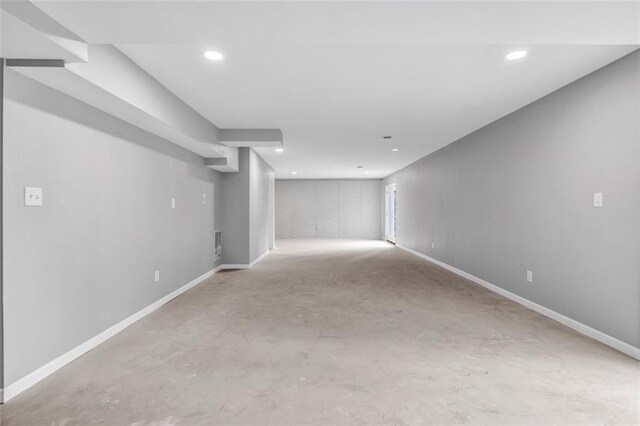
[0,266,222,403]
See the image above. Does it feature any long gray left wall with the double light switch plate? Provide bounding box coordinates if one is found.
[3,70,221,385]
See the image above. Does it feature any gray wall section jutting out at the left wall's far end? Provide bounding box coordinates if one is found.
[222,148,273,265]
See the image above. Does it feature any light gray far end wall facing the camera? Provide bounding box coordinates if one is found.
[275,179,382,239]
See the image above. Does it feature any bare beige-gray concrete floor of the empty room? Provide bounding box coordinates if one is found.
[2,241,640,426]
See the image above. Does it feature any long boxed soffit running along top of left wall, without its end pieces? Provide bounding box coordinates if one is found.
[8,45,237,164]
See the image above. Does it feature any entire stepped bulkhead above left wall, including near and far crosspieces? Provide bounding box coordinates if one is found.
[0,0,283,172]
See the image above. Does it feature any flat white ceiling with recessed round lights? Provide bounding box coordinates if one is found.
[30,1,640,178]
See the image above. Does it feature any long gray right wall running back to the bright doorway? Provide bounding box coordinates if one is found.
[385,51,640,347]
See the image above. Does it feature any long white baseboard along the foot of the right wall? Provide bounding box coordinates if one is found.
[398,245,640,360]
